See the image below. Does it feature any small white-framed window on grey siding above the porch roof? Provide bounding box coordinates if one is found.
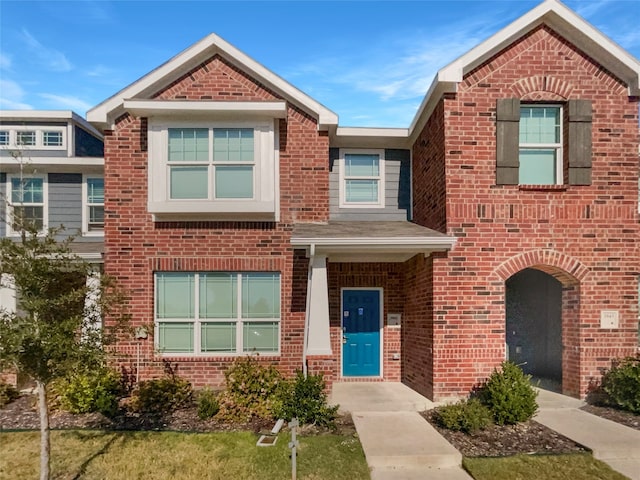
[339,149,384,208]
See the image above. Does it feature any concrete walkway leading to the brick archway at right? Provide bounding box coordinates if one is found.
[534,390,640,480]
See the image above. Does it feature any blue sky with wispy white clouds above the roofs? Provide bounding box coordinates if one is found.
[0,0,640,127]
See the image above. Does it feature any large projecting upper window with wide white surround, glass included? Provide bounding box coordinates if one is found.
[148,120,279,219]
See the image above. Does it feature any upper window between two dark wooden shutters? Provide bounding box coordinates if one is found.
[518,104,563,185]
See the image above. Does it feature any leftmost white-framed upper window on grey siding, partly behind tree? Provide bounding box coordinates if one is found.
[7,175,48,235]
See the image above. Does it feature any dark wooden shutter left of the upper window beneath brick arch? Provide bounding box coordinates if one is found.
[496,98,520,185]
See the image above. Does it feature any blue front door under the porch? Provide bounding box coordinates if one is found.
[342,290,380,377]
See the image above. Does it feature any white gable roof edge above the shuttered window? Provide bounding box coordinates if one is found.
[409,0,640,140]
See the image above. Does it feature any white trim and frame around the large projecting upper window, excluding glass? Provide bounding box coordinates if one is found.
[147,119,279,220]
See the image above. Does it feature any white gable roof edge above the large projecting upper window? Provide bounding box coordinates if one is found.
[87,33,338,129]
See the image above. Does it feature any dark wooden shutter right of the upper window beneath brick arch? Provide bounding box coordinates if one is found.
[568,100,592,185]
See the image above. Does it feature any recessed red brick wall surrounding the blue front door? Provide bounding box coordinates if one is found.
[327,262,404,382]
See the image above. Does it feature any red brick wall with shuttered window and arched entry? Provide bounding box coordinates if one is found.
[412,27,640,399]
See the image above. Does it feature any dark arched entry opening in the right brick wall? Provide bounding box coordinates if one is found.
[506,268,562,383]
